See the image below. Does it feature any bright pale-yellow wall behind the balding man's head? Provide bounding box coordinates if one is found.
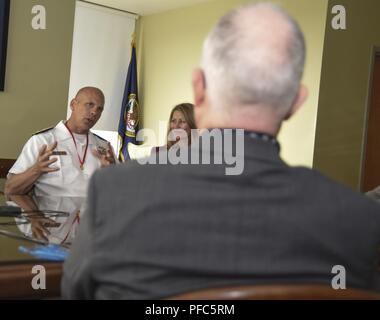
[137,0,327,166]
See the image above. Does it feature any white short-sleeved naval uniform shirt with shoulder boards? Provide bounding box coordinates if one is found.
[9,121,108,197]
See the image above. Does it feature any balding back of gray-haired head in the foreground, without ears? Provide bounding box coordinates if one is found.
[202,3,305,117]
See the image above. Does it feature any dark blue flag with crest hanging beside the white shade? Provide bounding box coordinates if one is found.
[118,44,140,162]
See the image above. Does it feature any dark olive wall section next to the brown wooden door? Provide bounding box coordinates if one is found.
[314,0,380,190]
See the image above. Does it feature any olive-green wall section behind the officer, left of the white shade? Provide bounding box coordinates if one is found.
[0,0,75,158]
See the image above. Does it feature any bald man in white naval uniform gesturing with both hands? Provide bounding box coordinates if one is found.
[4,87,115,196]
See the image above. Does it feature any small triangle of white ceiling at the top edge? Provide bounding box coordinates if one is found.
[87,0,210,16]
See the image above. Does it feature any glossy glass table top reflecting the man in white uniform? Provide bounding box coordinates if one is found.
[0,194,85,264]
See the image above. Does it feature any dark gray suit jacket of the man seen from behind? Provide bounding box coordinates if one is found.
[62,131,380,299]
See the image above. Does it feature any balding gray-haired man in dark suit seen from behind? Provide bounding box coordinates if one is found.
[62,4,380,299]
